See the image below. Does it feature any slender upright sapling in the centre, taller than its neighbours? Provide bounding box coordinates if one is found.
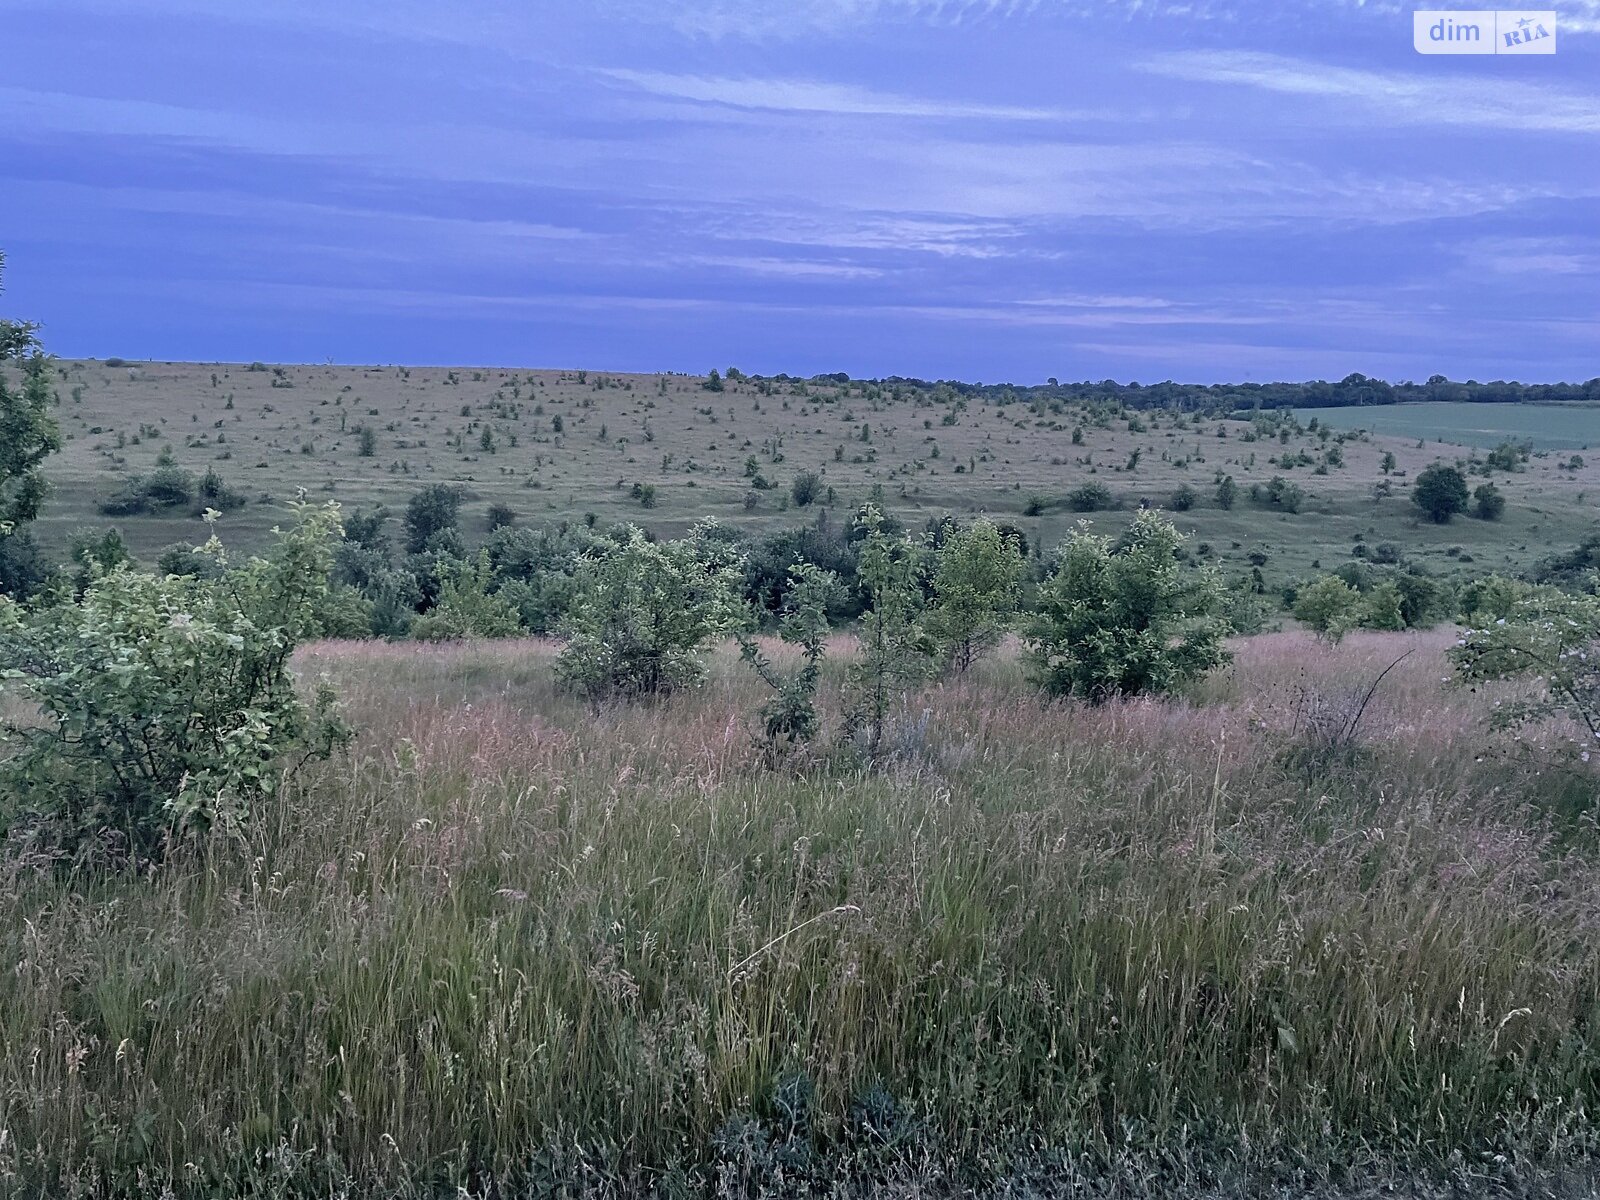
[845,504,931,758]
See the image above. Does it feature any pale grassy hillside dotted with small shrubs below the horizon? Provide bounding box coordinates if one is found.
[12,362,1600,595]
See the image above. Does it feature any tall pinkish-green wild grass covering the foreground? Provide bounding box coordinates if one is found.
[0,634,1600,1197]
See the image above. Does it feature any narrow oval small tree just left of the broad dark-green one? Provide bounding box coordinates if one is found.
[925,522,1024,674]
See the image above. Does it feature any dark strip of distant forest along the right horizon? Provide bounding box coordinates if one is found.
[758,371,1600,413]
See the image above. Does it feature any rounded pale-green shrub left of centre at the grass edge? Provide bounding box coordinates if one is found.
[555,525,741,704]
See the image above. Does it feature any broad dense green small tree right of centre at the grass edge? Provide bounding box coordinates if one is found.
[1027,510,1229,704]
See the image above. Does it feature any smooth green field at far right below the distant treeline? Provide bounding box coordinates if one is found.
[1298,402,1600,451]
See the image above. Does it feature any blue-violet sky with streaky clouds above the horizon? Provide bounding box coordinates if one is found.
[0,0,1600,382]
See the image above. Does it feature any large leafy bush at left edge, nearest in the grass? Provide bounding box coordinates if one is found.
[0,506,347,859]
